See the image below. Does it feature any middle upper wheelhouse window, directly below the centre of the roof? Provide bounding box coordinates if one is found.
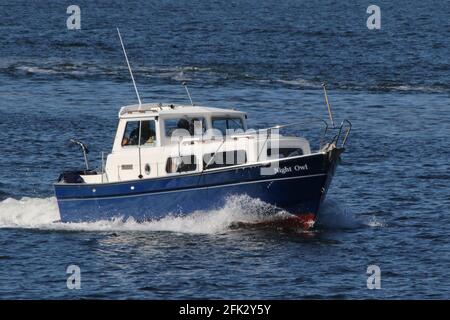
[164,117,206,137]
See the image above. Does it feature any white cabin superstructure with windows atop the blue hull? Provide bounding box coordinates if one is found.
[82,104,311,183]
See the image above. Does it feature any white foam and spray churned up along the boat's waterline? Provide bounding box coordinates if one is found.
[0,196,380,234]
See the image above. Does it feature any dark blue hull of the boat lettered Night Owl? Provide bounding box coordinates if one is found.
[55,149,340,222]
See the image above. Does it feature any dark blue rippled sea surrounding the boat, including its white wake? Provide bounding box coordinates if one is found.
[0,0,450,299]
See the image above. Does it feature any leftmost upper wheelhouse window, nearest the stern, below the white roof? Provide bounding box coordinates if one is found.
[122,120,156,147]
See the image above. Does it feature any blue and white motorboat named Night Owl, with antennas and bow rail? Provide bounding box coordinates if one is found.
[54,29,351,229]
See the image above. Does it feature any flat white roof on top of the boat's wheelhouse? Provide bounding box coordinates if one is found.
[119,103,245,118]
